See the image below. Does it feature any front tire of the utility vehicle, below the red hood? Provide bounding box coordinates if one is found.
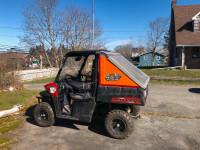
[34,102,55,127]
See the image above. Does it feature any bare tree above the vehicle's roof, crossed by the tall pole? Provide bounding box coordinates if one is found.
[63,6,104,50]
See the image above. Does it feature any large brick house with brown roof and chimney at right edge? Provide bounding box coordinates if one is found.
[169,0,200,69]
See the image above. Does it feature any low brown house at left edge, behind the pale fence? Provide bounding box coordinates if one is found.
[0,52,39,69]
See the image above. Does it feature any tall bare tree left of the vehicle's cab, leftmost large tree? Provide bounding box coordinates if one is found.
[20,0,62,67]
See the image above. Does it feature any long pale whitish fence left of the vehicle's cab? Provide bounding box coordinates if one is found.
[15,68,58,81]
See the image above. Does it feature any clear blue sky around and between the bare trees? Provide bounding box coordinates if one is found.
[0,0,200,51]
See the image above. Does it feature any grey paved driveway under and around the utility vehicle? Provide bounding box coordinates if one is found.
[13,85,200,150]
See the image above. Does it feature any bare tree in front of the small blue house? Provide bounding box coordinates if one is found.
[147,17,169,66]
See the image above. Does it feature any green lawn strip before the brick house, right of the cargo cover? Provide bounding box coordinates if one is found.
[141,69,200,78]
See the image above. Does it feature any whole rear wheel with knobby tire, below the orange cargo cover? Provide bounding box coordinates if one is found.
[105,110,133,139]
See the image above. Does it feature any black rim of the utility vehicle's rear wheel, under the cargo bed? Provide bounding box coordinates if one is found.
[111,118,126,134]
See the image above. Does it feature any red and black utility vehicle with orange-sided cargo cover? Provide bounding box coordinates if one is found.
[34,50,150,139]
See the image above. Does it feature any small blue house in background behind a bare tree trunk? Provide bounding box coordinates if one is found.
[138,52,165,67]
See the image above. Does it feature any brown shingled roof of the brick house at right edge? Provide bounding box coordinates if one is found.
[174,5,200,45]
